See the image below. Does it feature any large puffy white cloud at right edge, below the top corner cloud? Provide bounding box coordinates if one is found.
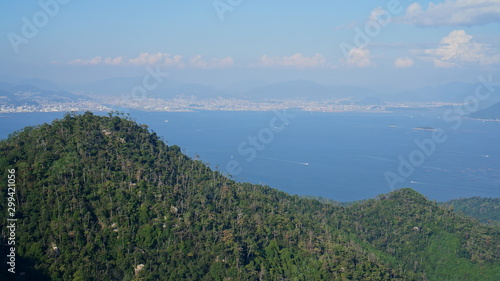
[425,30,500,67]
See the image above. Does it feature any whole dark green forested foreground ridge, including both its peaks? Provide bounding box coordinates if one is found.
[0,113,500,280]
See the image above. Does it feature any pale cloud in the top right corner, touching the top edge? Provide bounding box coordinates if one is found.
[399,0,500,26]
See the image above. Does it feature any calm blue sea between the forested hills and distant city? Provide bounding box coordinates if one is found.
[0,110,500,202]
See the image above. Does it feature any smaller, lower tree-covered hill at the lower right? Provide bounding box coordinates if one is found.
[352,189,500,280]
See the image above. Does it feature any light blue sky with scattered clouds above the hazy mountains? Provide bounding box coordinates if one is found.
[0,0,500,91]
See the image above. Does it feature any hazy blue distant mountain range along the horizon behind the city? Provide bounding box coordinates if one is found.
[0,76,500,105]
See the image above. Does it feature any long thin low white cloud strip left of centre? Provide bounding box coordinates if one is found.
[63,52,234,69]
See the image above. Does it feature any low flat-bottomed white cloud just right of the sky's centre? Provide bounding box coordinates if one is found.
[250,53,331,69]
